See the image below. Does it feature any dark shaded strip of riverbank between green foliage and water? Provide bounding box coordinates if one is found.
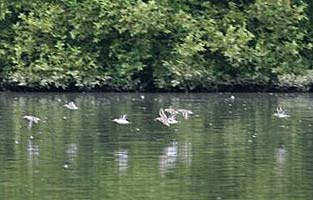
[0,77,313,93]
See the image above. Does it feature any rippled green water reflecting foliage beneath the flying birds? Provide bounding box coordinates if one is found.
[0,93,313,200]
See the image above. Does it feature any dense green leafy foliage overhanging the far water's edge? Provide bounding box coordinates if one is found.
[0,0,313,90]
